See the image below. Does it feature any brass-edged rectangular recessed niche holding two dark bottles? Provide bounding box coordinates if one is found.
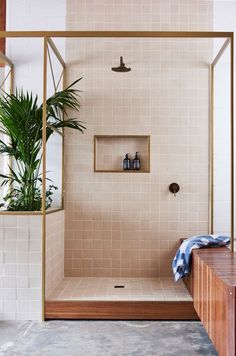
[94,135,150,173]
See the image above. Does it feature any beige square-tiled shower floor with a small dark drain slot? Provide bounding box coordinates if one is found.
[47,277,192,301]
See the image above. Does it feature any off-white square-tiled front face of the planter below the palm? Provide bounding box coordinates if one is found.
[0,215,42,320]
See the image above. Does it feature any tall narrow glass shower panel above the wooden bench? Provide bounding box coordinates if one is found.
[213,46,231,235]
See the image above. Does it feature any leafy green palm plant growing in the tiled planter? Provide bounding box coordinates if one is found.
[0,78,85,211]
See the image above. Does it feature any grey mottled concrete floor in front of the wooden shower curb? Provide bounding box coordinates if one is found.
[0,321,217,356]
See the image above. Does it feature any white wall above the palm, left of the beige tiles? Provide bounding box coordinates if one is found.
[6,0,66,96]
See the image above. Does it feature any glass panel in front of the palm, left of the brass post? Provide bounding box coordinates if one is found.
[0,37,43,211]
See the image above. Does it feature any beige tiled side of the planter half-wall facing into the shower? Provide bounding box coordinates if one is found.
[45,211,64,298]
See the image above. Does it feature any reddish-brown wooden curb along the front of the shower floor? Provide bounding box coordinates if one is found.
[45,301,199,320]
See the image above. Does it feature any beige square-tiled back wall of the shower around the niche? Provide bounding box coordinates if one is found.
[65,0,212,277]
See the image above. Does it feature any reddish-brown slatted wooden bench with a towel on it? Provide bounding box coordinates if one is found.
[184,247,236,356]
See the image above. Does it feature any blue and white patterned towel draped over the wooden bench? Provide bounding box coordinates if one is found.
[172,235,230,282]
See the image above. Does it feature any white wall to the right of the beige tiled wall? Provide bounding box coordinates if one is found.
[214,1,236,233]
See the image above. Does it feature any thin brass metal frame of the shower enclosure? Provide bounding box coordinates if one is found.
[0,31,234,320]
